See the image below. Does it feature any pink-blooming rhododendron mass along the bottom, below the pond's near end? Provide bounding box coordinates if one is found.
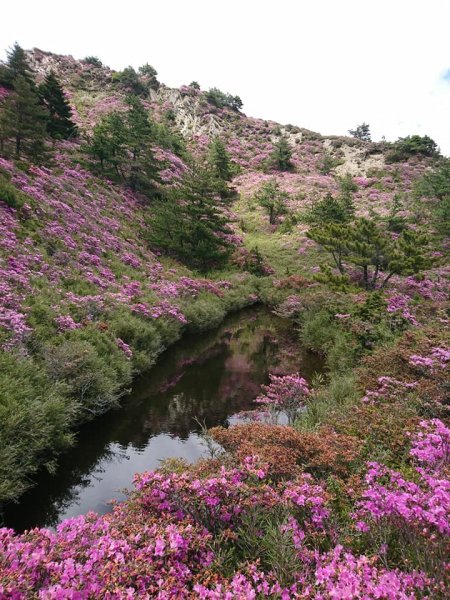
[0,450,442,599]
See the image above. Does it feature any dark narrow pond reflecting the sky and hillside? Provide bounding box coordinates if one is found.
[3,307,321,531]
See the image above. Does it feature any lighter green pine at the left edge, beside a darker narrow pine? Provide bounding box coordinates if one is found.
[0,75,48,159]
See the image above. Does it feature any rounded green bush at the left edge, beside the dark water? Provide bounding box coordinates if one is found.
[0,352,75,501]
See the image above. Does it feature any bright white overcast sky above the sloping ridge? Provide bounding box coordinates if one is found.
[0,0,450,156]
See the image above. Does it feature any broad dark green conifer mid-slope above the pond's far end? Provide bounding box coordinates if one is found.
[149,165,231,271]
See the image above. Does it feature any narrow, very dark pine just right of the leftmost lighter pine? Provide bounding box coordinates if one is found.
[38,71,77,140]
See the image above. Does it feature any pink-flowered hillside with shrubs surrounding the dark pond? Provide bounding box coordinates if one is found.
[0,49,450,598]
